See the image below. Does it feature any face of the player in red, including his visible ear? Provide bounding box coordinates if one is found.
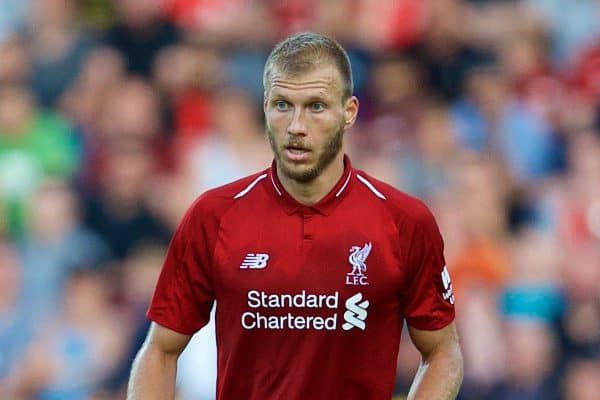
[264,64,358,182]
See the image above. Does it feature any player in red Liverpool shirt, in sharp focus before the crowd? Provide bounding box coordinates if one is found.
[129,33,463,400]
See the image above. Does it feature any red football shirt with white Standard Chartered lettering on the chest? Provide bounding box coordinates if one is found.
[148,157,454,400]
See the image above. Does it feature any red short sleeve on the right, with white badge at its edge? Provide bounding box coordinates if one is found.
[404,205,454,330]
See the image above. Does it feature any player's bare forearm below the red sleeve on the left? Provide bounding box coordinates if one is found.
[127,322,191,400]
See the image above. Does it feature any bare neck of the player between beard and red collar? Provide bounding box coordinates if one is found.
[277,152,344,206]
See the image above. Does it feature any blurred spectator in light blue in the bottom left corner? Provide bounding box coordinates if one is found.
[9,270,124,400]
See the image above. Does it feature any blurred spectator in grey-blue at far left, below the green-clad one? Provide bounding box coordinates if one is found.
[19,180,110,321]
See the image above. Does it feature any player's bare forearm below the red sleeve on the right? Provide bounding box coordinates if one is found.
[408,323,463,400]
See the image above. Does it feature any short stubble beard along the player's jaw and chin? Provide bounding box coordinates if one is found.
[266,125,345,183]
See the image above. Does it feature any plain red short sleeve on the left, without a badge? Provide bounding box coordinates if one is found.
[147,199,214,335]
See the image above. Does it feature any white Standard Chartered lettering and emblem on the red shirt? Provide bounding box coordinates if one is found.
[241,290,369,331]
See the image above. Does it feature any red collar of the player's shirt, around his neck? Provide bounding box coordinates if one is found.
[267,154,354,215]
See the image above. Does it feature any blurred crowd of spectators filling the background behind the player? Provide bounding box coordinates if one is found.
[0,0,600,400]
